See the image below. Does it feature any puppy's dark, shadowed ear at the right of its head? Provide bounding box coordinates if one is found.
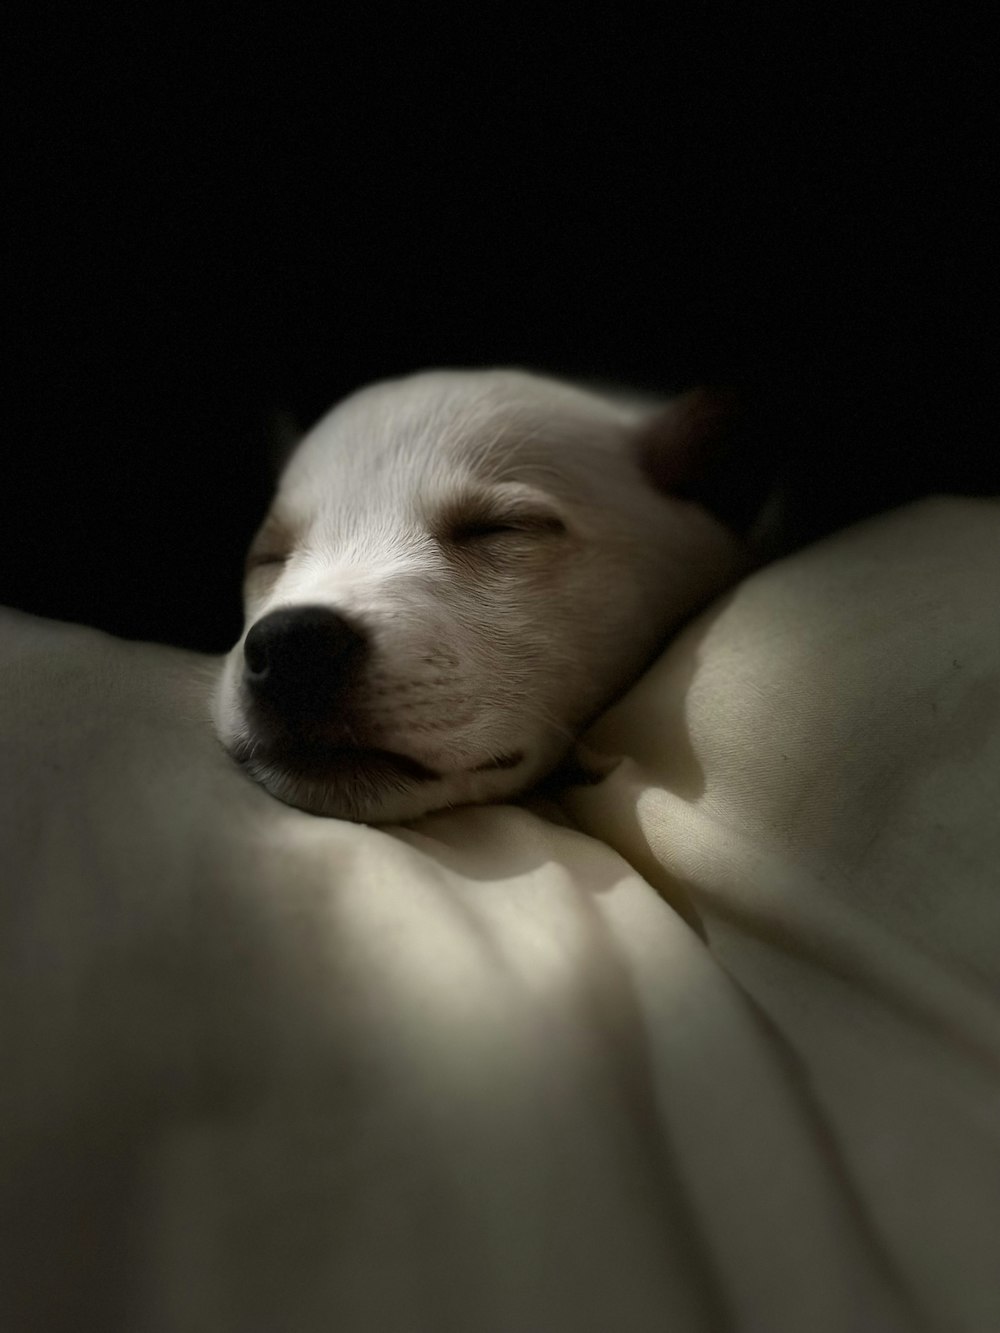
[635,388,773,533]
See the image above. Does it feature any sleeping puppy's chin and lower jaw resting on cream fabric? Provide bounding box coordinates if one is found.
[231,742,541,824]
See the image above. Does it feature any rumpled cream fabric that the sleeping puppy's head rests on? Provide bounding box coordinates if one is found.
[0,500,1000,1333]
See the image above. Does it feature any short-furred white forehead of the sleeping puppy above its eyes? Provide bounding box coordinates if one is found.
[281,371,636,503]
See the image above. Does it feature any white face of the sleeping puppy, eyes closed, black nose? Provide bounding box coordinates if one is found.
[215,371,741,822]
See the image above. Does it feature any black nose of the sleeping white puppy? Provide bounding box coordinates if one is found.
[243,607,368,720]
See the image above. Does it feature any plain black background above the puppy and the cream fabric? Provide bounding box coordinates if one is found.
[0,4,997,651]
